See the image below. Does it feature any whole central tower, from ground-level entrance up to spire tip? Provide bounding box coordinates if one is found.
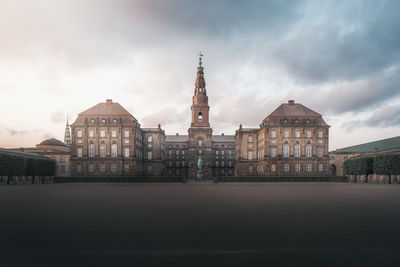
[188,53,212,178]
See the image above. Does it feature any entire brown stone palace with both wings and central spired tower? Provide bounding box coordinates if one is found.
[69,54,330,178]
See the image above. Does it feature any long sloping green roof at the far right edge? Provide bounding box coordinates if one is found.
[334,136,400,153]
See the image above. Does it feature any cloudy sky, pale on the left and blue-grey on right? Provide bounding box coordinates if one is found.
[0,0,400,150]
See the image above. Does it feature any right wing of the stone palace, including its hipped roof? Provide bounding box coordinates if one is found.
[235,100,330,176]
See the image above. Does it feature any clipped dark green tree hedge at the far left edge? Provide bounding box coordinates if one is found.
[0,153,57,176]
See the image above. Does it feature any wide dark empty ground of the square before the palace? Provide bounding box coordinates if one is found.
[0,183,400,266]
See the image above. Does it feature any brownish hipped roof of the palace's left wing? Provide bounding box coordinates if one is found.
[71,99,137,126]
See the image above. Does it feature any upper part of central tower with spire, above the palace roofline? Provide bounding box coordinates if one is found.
[190,53,210,127]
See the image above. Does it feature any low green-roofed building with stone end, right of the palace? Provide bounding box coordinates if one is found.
[329,136,400,176]
